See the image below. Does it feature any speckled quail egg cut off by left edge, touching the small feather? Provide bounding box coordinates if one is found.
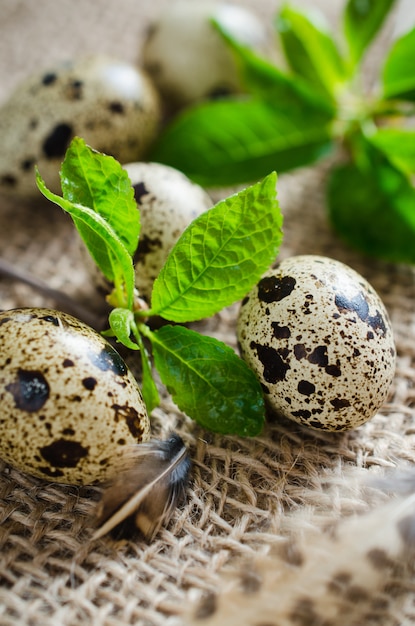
[0,308,149,484]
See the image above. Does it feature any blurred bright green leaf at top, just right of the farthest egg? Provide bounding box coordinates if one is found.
[276,5,346,98]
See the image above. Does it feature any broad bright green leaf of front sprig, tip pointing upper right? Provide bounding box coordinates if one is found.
[150,172,282,322]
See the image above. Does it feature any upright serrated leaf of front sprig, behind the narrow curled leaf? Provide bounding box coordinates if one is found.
[60,137,140,256]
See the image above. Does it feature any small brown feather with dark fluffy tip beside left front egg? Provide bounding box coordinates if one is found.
[92,433,191,540]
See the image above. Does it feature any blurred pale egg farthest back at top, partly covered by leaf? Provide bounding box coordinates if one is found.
[140,0,269,106]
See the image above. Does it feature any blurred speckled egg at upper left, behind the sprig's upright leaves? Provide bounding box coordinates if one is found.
[0,56,161,195]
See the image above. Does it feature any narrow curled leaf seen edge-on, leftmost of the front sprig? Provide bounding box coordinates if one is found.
[36,170,135,308]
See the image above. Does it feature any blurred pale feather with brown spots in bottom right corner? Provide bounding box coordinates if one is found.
[184,469,415,626]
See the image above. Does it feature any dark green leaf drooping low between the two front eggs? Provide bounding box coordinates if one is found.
[151,326,265,437]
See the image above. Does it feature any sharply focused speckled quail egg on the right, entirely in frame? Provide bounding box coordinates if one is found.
[237,255,396,431]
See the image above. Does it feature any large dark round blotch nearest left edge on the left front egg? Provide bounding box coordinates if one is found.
[5,369,50,413]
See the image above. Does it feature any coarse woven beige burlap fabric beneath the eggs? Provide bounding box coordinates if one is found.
[0,0,415,626]
